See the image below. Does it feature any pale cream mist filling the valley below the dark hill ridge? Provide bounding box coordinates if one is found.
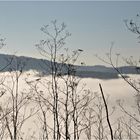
[0,67,140,140]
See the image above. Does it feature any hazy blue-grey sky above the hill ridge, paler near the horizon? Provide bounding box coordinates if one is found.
[0,1,140,65]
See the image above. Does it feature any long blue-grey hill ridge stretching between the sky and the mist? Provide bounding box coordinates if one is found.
[0,54,140,79]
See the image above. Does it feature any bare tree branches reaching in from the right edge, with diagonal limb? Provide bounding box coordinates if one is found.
[96,14,140,139]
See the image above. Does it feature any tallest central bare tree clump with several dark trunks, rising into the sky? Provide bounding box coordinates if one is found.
[32,20,102,140]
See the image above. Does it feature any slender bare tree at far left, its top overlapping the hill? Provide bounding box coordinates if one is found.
[0,57,36,140]
